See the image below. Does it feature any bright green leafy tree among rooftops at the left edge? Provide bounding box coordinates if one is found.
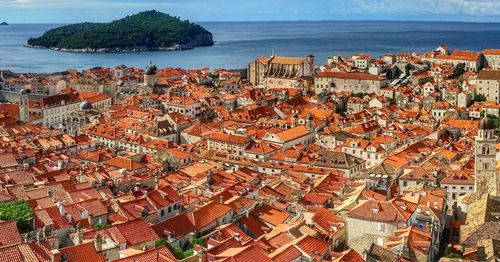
[0,200,33,233]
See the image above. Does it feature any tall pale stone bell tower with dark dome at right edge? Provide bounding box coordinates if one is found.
[474,117,500,197]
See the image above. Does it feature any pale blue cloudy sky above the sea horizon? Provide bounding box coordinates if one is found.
[0,0,500,23]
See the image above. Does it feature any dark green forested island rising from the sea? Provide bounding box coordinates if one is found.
[26,10,214,53]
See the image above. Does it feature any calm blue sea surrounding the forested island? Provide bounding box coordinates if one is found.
[0,21,500,72]
